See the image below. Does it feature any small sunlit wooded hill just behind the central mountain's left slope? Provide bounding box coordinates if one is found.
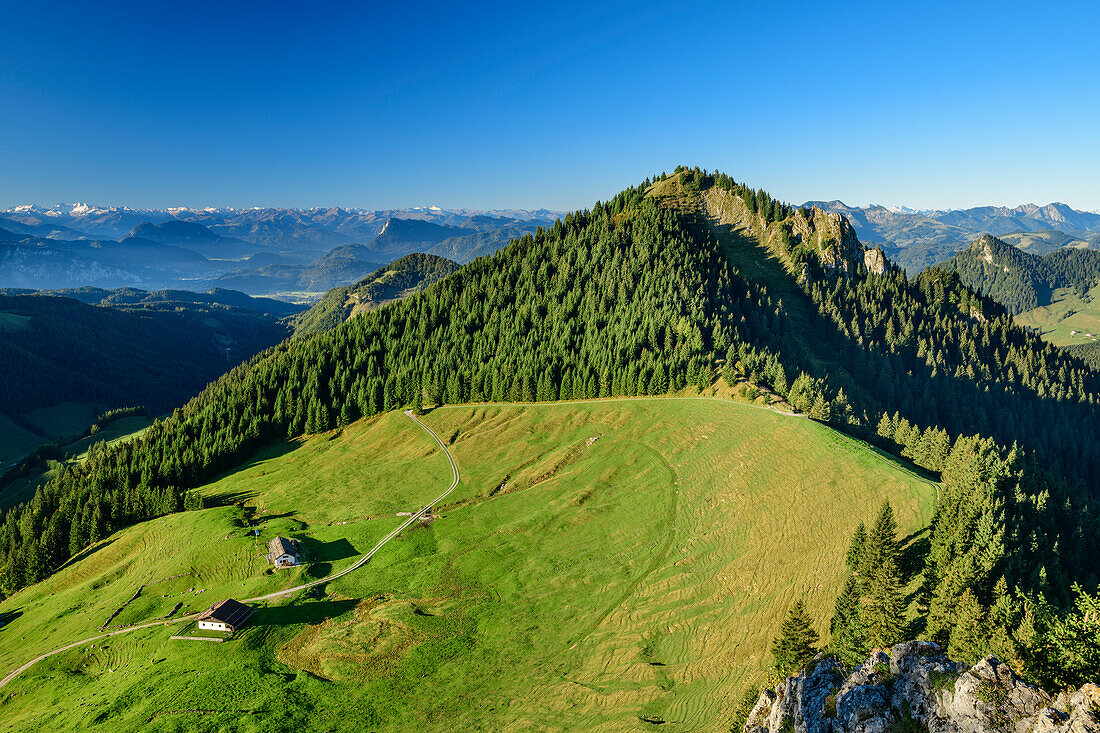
[294,249,459,336]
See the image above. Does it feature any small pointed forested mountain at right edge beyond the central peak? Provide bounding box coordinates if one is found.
[937,234,1100,314]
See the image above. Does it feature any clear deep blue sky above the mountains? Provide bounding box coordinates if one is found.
[0,0,1100,209]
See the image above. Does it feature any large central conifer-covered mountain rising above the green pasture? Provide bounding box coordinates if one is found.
[0,168,1100,686]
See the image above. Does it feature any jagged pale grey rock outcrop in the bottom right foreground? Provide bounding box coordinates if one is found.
[744,642,1100,733]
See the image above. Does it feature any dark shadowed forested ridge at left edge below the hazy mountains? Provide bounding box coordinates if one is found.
[0,291,287,418]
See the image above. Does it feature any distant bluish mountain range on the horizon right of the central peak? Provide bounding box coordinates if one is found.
[803,200,1100,273]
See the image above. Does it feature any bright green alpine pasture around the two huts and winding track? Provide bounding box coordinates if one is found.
[0,400,935,731]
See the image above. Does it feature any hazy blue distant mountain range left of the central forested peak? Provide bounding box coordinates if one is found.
[0,205,558,295]
